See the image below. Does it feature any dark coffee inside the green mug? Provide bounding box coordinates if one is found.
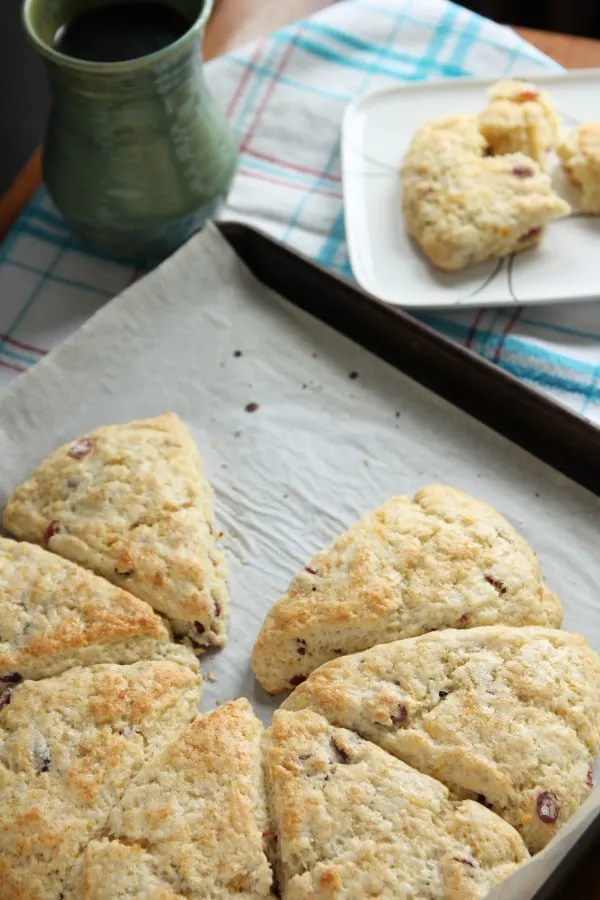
[54,0,191,62]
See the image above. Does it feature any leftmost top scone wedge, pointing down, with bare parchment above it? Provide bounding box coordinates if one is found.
[3,413,229,651]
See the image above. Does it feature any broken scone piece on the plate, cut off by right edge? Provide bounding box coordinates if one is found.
[556,122,600,215]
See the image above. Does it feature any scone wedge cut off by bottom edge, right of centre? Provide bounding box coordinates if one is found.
[265,710,529,900]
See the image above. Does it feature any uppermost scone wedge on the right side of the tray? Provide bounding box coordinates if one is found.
[252,485,562,694]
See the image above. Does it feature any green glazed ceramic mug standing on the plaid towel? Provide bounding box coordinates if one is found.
[23,0,238,262]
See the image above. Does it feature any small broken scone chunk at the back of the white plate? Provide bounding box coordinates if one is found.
[479,81,559,166]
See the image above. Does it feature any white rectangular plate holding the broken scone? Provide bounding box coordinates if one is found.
[342,69,600,309]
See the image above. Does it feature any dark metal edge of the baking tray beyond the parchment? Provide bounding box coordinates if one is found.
[219,222,600,900]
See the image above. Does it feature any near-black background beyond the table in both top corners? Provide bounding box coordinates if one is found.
[0,0,600,194]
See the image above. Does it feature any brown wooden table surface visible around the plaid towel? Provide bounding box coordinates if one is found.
[0,0,600,900]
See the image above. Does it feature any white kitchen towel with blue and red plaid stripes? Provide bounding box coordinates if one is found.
[0,0,600,420]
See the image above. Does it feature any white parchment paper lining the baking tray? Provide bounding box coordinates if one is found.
[0,226,600,900]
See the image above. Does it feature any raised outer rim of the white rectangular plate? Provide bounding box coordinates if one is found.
[340,66,600,311]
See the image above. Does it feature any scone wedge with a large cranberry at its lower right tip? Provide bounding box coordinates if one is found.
[284,625,600,851]
